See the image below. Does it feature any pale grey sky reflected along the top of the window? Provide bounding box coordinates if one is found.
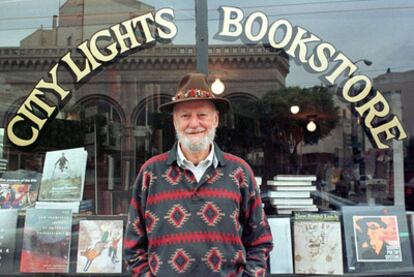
[0,0,414,86]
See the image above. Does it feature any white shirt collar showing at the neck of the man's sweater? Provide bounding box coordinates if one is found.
[177,143,218,183]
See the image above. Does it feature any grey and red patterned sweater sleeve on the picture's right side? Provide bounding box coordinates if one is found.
[241,168,273,276]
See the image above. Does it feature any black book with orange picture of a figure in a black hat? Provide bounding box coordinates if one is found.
[342,206,413,273]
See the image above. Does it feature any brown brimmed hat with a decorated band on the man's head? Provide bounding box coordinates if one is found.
[159,73,230,113]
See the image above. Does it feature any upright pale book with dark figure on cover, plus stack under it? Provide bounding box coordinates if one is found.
[35,148,93,213]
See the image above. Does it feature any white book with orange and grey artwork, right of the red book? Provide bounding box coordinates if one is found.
[76,220,123,273]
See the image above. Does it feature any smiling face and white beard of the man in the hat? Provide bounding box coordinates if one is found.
[173,100,219,152]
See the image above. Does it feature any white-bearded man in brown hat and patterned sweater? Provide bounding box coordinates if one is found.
[124,73,272,276]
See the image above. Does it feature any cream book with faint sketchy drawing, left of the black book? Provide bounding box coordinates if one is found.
[293,213,343,275]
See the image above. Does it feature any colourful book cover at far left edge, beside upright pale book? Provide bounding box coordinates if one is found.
[0,178,39,210]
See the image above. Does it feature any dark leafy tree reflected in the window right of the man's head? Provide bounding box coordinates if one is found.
[219,86,339,179]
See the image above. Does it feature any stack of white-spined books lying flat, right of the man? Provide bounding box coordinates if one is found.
[262,175,318,214]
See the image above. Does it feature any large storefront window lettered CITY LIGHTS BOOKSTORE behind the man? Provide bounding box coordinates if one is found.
[0,0,414,275]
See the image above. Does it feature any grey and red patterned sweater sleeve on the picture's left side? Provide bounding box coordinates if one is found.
[124,170,152,277]
